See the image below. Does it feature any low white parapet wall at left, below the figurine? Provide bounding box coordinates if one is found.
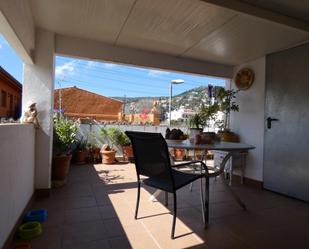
[0,124,35,248]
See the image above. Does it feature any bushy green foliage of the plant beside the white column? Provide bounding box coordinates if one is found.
[53,116,78,155]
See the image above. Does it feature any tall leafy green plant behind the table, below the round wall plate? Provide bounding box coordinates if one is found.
[216,88,239,130]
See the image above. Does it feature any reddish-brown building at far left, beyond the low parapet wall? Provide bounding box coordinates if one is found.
[0,67,22,119]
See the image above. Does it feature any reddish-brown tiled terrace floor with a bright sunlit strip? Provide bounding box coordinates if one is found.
[15,163,309,249]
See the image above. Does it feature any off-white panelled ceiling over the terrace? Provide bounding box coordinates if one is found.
[29,0,309,65]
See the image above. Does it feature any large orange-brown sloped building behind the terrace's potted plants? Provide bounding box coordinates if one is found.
[54,86,123,121]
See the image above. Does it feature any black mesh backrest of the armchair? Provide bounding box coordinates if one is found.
[125,131,173,182]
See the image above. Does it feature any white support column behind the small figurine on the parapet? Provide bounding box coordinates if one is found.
[22,29,55,189]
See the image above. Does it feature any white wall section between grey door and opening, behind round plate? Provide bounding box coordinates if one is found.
[231,57,266,181]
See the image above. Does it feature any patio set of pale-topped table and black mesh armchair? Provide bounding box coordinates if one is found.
[126,129,255,239]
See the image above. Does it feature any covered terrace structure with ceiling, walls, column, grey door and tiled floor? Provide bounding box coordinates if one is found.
[0,0,309,248]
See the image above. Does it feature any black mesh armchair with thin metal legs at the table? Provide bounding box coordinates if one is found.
[126,131,209,239]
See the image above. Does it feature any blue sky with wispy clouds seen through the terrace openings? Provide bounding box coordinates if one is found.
[0,35,224,97]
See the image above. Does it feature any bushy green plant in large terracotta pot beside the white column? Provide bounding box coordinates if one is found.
[52,116,78,181]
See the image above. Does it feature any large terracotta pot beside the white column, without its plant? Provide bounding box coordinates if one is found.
[52,154,72,181]
